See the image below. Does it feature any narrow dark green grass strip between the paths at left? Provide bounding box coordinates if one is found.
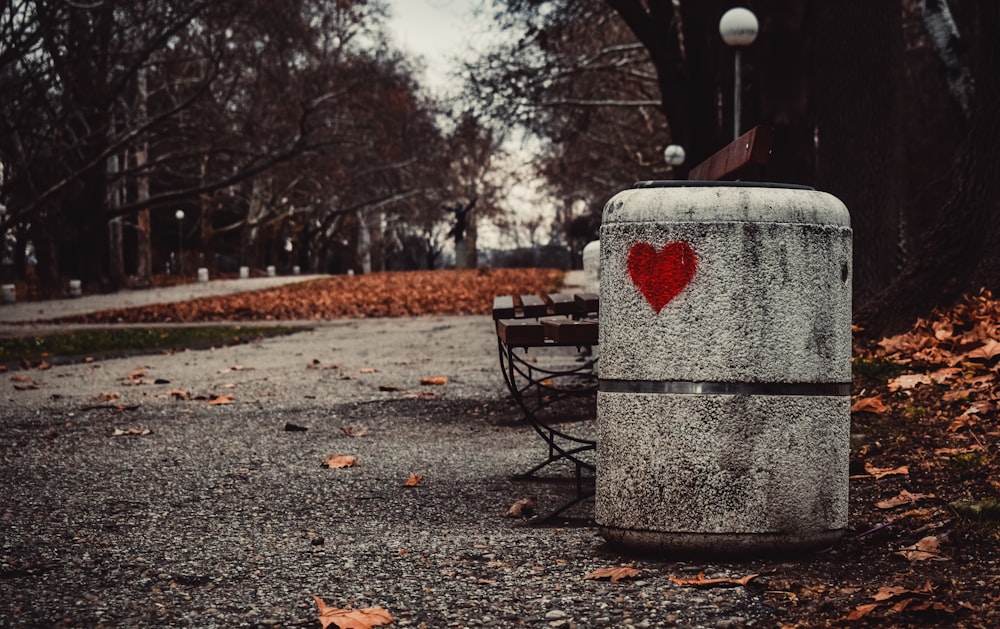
[0,325,309,364]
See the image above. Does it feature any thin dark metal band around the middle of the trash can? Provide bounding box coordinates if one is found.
[598,380,851,397]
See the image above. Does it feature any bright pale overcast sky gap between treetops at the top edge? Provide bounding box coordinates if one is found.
[387,0,488,91]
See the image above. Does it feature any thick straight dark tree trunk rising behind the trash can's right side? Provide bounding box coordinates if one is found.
[813,0,903,305]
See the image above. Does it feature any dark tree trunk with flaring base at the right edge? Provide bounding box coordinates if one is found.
[855,0,1000,338]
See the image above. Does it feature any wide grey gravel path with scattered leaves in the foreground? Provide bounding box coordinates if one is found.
[0,317,779,629]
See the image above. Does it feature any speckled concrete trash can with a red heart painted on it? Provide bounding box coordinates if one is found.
[595,182,851,555]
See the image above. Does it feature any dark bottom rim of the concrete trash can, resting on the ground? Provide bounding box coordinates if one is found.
[599,526,846,557]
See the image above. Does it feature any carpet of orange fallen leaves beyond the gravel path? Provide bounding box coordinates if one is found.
[61,269,563,323]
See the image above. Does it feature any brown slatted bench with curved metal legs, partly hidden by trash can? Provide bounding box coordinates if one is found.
[493,126,774,521]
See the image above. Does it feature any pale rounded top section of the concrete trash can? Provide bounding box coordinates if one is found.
[602,181,851,228]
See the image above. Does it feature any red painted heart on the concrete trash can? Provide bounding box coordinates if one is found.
[628,241,698,314]
